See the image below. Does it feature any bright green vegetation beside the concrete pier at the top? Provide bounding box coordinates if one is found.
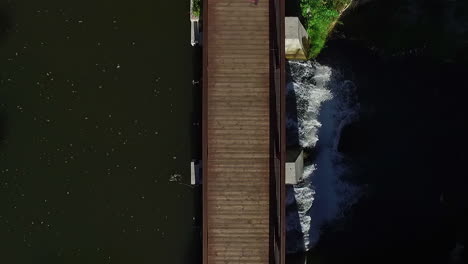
[300,0,352,58]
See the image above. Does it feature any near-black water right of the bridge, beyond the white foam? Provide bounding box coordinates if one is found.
[286,0,468,264]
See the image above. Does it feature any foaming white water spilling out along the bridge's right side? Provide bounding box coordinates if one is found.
[287,62,359,252]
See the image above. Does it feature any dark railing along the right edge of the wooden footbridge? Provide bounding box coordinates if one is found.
[269,0,286,264]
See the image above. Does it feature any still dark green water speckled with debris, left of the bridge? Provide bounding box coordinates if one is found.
[0,0,200,264]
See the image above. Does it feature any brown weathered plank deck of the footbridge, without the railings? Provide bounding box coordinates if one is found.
[204,0,270,264]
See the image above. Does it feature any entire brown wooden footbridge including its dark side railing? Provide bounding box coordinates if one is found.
[202,0,285,264]
